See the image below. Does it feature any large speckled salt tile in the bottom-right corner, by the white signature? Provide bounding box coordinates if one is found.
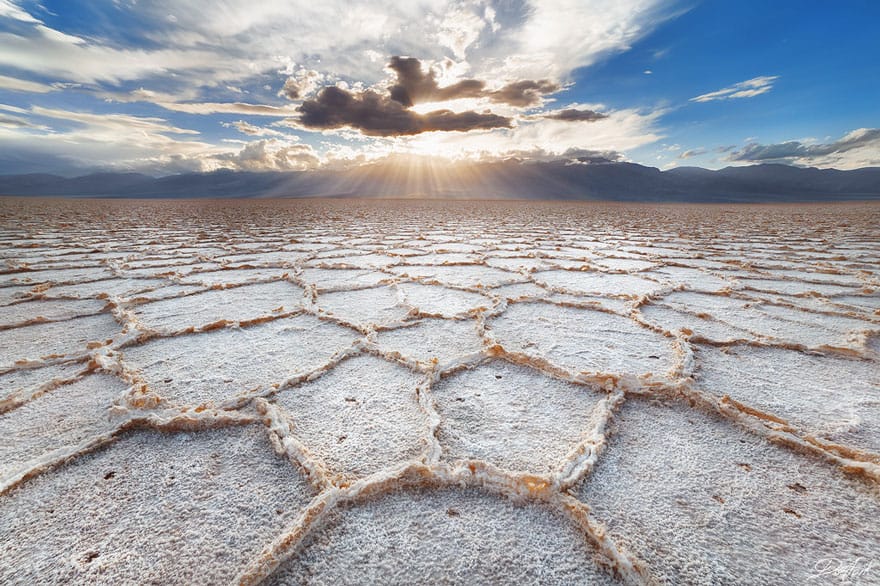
[580,400,880,584]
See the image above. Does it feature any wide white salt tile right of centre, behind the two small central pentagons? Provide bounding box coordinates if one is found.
[487,302,677,376]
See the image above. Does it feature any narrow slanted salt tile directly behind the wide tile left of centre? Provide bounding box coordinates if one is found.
[133,281,303,333]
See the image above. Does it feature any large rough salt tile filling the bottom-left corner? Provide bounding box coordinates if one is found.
[0,425,313,584]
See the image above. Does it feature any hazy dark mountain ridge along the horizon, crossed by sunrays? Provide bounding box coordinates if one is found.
[0,160,880,202]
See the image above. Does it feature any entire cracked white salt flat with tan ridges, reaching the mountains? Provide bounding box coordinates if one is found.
[0,199,880,584]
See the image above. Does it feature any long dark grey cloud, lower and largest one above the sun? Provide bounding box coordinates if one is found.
[298,86,511,136]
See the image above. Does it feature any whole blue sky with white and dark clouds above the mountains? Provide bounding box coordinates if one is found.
[0,0,880,176]
